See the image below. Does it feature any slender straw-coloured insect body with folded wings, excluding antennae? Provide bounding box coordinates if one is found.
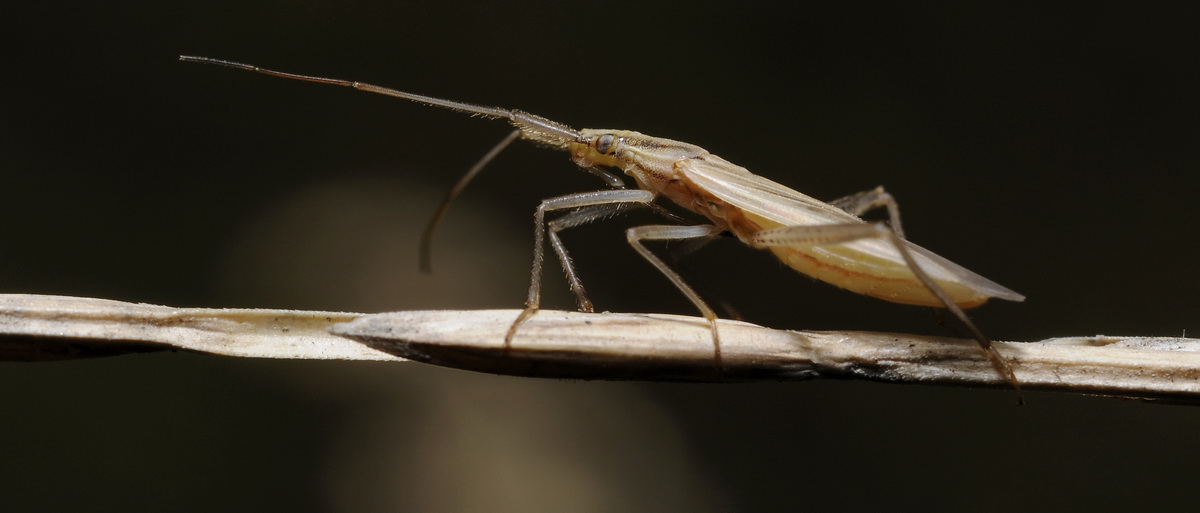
[572,129,1024,308]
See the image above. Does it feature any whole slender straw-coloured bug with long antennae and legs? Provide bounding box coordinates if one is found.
[180,55,1025,402]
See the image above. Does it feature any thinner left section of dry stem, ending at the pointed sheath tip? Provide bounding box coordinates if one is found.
[0,294,403,361]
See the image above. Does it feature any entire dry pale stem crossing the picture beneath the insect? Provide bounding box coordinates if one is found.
[0,295,1200,403]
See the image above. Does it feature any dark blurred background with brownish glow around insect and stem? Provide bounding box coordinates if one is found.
[0,1,1200,512]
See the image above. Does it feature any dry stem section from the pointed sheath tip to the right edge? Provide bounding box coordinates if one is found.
[334,310,1200,403]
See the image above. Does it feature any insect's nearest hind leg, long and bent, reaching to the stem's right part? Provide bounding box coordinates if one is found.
[750,223,1024,404]
